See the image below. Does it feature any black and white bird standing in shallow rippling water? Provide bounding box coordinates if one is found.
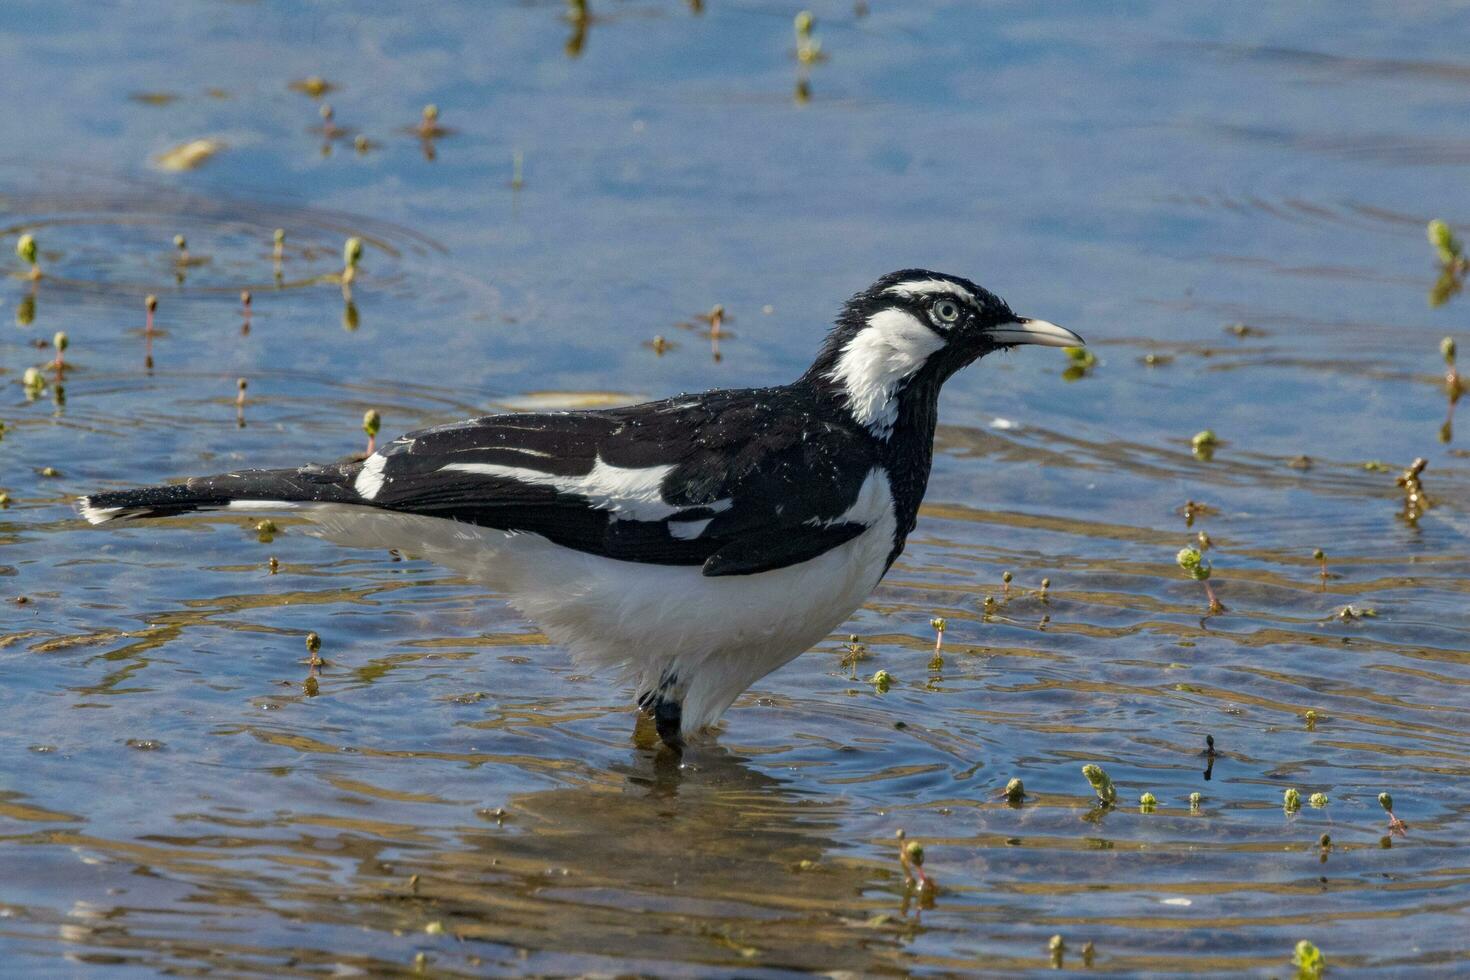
[81,269,1082,748]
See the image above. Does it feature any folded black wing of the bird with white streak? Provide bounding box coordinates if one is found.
[356,389,886,576]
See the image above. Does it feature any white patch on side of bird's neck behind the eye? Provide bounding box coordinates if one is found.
[828,307,945,439]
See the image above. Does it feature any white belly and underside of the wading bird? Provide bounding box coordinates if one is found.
[309,479,895,732]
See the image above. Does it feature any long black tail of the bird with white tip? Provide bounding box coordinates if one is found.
[78,463,369,525]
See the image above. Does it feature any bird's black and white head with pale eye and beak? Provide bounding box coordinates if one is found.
[804,269,1083,438]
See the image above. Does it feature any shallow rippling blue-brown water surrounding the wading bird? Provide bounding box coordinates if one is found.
[0,0,1470,976]
